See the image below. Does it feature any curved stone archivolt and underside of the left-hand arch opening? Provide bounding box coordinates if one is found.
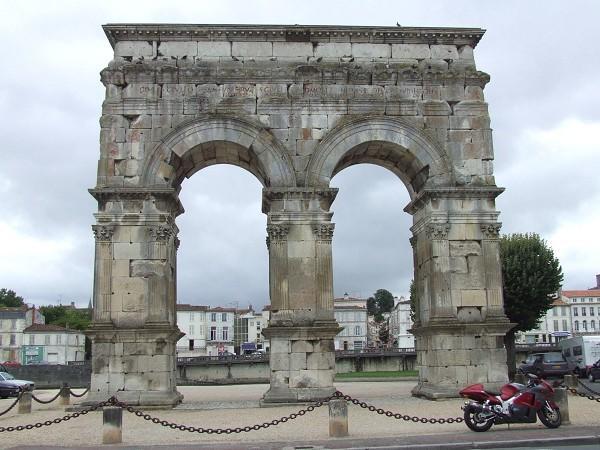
[141,116,296,187]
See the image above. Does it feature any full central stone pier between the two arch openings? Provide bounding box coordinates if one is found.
[262,188,340,403]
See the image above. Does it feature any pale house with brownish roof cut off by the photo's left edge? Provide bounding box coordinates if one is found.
[0,305,45,364]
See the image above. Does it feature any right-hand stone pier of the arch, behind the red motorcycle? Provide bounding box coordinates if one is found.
[406,187,512,398]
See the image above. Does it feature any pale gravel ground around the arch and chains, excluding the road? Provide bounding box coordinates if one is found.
[0,381,600,448]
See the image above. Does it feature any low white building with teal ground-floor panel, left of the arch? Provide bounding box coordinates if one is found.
[21,323,85,364]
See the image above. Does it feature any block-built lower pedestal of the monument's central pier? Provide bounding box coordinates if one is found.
[262,322,341,403]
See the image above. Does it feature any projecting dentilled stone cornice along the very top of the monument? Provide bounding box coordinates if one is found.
[102,23,485,48]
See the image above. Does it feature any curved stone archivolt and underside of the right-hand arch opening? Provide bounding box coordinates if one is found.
[307,116,452,199]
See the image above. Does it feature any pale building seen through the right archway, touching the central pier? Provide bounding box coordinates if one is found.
[333,294,367,350]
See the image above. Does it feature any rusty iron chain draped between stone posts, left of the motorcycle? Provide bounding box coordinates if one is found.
[0,390,464,434]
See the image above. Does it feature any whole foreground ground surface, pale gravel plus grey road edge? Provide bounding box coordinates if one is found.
[0,381,600,449]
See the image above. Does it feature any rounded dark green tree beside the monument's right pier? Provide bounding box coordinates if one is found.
[500,233,563,379]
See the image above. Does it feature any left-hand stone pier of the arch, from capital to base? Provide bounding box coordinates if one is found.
[83,188,182,407]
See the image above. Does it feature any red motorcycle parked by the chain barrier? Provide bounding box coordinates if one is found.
[460,374,562,431]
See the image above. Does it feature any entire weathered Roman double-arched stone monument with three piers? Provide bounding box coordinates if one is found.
[87,24,511,407]
